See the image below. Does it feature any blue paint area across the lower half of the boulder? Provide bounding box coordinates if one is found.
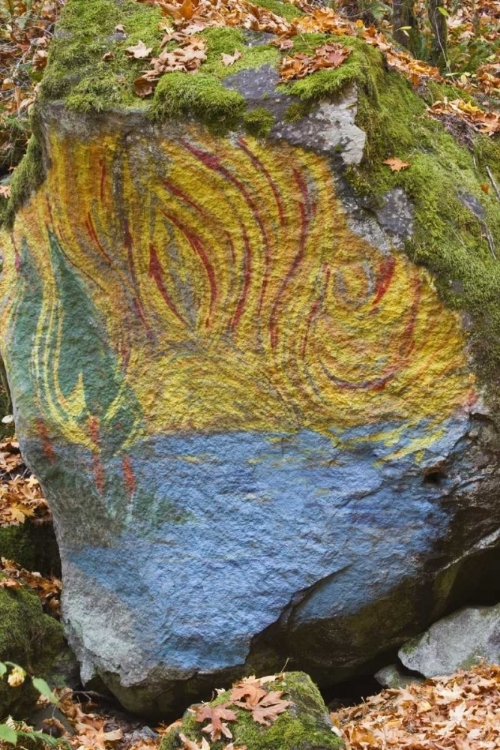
[59,419,468,671]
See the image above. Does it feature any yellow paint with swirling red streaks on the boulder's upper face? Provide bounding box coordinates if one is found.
[2,128,473,449]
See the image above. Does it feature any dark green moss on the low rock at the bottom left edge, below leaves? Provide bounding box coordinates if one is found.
[0,589,65,719]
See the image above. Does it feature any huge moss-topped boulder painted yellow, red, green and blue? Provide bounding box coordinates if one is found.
[1,0,500,714]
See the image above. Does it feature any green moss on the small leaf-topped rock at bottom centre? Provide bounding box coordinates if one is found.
[160,672,341,750]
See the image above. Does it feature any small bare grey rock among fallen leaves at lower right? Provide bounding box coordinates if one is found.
[399,604,500,677]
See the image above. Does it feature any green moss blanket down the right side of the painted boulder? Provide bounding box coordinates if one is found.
[332,43,500,405]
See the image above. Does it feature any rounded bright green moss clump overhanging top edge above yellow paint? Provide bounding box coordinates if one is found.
[151,73,246,133]
